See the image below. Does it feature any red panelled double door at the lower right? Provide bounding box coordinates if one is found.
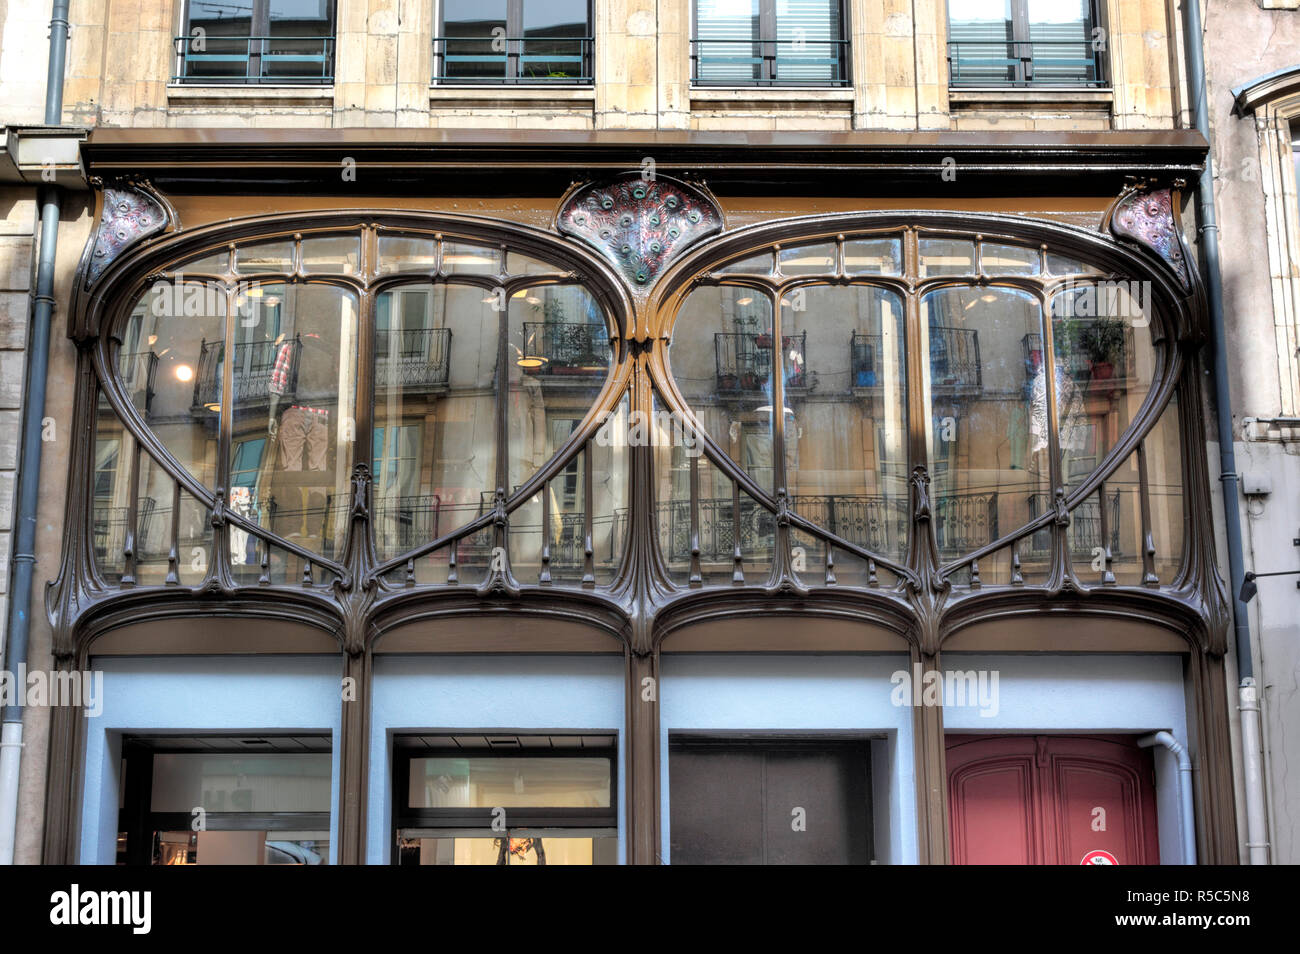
[945,736,1160,864]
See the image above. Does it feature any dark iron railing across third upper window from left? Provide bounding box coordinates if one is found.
[690,38,849,86]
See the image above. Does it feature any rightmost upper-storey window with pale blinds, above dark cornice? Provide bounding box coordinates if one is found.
[948,0,1105,86]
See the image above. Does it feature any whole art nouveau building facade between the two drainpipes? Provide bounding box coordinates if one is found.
[0,3,1258,863]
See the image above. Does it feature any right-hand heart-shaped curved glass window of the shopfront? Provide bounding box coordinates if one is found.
[660,230,1180,582]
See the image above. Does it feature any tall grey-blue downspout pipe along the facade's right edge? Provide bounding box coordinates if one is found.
[1182,0,1269,864]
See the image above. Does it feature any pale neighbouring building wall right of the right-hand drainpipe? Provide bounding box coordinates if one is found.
[1205,0,1300,864]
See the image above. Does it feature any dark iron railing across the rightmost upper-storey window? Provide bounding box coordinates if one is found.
[948,38,1105,87]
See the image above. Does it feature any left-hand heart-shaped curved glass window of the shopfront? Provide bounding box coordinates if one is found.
[105,227,612,582]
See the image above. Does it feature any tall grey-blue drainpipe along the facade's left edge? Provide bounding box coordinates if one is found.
[0,0,70,864]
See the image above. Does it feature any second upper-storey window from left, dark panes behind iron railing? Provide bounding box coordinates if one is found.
[433,0,594,86]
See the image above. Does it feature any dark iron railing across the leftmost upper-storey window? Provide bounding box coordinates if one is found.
[172,34,334,86]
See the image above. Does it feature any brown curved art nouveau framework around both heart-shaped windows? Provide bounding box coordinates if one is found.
[45,202,1222,649]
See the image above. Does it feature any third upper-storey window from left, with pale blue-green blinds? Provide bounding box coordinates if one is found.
[690,0,849,86]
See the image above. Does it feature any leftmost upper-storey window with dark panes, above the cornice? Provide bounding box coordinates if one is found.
[173,0,334,86]
